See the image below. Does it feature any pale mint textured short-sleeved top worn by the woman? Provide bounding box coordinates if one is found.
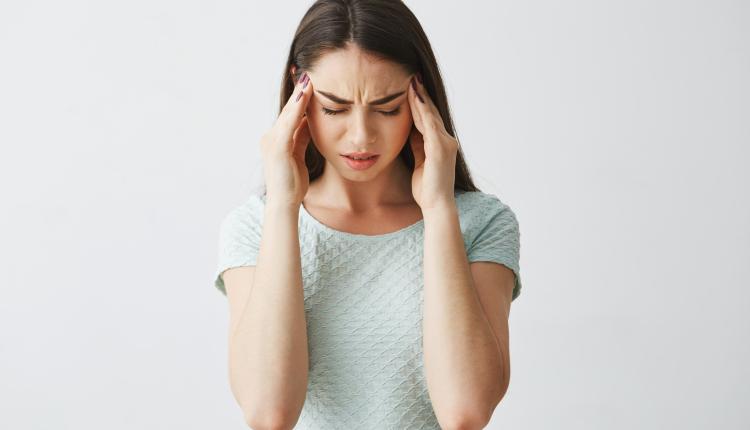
[214,191,521,430]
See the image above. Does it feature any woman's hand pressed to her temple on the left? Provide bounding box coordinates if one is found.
[260,73,312,207]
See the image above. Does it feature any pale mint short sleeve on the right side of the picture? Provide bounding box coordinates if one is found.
[467,194,521,301]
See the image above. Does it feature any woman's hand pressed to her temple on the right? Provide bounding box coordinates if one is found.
[408,76,458,210]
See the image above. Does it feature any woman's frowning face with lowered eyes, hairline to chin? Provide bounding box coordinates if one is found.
[306,45,413,181]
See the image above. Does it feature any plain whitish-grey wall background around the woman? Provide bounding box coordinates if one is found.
[0,0,750,429]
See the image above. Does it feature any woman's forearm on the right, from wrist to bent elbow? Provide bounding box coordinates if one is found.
[423,203,505,428]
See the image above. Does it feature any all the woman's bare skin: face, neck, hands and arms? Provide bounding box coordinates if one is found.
[224,41,515,429]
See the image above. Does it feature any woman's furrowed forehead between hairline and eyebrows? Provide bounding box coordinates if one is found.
[310,46,409,98]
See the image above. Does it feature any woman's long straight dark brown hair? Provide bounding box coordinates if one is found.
[279,0,479,191]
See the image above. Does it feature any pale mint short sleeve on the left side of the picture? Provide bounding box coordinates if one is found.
[214,197,262,296]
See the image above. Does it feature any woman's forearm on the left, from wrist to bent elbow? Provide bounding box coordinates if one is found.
[229,205,308,422]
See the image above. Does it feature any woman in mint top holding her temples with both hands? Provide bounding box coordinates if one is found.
[215,0,521,429]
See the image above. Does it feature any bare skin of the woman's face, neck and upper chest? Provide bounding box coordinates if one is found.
[292,45,422,235]
